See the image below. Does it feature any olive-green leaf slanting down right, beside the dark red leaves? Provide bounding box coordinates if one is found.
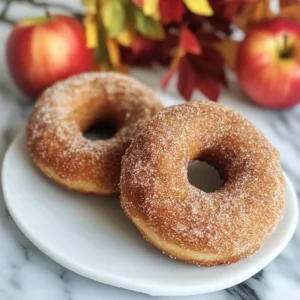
[132,5,165,40]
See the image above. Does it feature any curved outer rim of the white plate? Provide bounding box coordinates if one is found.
[1,130,299,296]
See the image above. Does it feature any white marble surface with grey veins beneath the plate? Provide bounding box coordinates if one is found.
[0,1,300,300]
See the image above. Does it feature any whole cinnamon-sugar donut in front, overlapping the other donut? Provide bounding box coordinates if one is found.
[120,101,285,266]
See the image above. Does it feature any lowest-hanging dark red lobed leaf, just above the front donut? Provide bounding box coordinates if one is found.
[177,56,220,101]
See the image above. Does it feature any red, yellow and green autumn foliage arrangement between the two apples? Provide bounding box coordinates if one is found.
[82,0,300,101]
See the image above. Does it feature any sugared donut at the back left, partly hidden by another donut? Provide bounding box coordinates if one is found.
[27,72,162,196]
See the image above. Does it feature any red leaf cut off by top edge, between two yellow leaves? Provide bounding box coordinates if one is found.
[159,0,184,24]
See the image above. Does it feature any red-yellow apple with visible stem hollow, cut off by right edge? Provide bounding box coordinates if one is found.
[236,18,300,109]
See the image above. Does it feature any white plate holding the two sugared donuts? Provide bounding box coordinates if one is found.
[2,133,298,296]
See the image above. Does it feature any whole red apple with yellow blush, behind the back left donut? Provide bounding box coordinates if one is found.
[6,15,93,97]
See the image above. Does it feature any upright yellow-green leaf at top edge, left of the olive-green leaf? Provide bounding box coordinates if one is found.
[101,0,127,37]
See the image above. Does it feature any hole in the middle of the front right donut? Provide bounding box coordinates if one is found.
[188,160,224,193]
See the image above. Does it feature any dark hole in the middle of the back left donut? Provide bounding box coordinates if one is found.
[83,122,118,141]
